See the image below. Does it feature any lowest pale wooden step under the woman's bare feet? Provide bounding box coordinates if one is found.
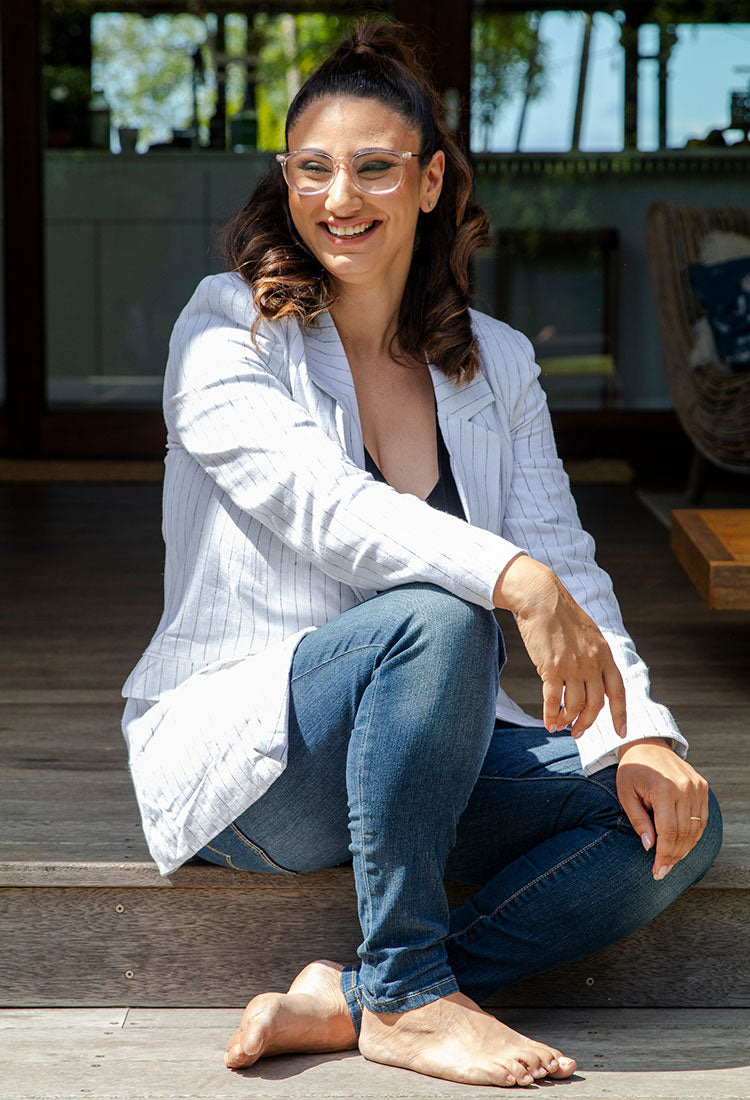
[0,1007,750,1100]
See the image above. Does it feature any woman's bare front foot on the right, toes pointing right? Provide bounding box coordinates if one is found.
[360,993,575,1087]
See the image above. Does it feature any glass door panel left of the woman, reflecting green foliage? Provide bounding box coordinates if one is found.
[42,0,391,407]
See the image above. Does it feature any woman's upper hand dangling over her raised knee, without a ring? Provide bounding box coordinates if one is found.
[494,554,626,737]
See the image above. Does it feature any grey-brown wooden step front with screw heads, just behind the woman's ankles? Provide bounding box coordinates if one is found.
[0,854,750,1008]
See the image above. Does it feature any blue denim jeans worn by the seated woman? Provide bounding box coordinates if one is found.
[198,584,721,1032]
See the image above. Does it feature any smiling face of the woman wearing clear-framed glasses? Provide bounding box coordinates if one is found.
[289,96,445,286]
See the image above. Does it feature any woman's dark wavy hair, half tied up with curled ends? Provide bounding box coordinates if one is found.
[221,19,487,386]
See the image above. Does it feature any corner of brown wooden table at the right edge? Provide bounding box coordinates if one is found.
[671,508,750,611]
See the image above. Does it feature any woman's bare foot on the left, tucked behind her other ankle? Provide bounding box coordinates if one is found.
[224,959,356,1069]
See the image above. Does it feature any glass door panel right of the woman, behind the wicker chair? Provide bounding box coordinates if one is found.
[472,0,750,408]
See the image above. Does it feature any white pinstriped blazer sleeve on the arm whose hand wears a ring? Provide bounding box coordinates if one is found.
[485,322,687,772]
